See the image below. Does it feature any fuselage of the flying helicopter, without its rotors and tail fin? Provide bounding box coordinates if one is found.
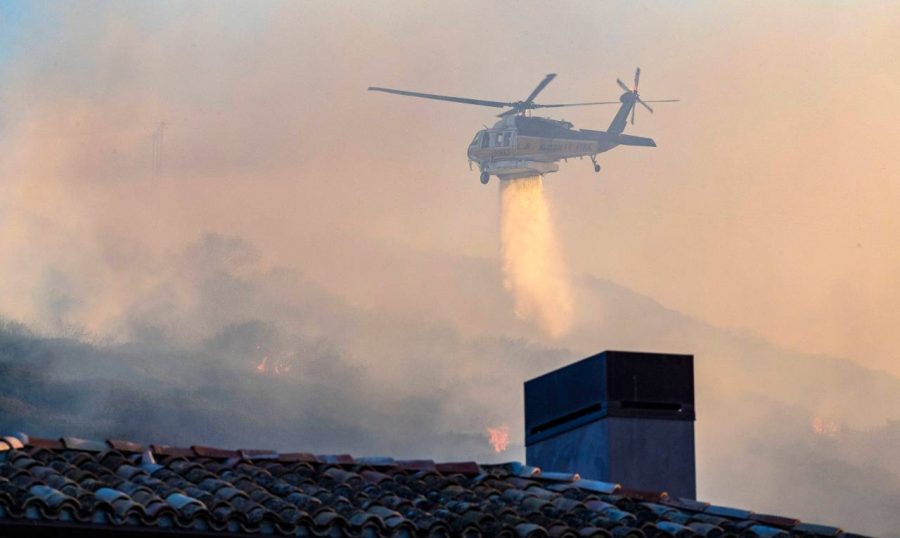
[468,115,656,179]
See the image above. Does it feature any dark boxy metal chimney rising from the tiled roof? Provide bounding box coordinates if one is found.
[525,351,697,499]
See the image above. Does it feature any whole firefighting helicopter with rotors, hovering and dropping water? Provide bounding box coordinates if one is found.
[368,67,679,184]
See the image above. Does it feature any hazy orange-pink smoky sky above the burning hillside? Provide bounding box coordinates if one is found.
[0,1,900,528]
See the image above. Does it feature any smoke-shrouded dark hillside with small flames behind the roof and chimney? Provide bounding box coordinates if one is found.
[0,231,900,536]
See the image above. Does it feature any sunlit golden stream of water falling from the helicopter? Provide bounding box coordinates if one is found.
[500,177,572,338]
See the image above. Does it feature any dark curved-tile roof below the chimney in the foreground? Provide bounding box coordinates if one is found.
[0,434,856,538]
